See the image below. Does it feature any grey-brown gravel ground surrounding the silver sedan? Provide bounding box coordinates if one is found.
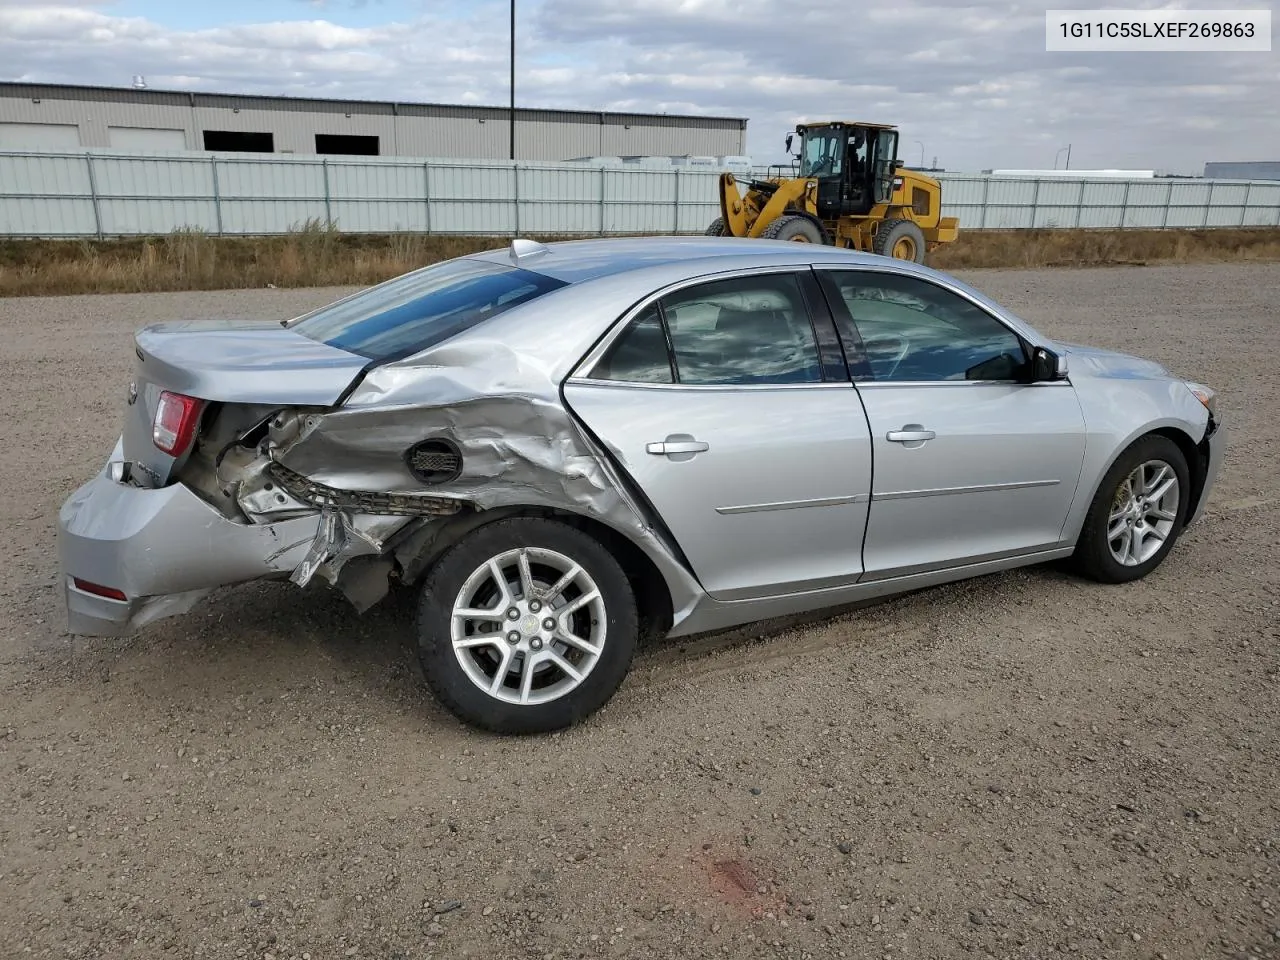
[0,265,1280,960]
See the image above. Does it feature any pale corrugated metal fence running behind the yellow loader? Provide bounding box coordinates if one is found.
[0,151,1280,237]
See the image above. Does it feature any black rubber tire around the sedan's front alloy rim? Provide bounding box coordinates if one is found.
[1071,434,1190,584]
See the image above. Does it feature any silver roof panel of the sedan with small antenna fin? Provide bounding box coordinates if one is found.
[472,237,901,283]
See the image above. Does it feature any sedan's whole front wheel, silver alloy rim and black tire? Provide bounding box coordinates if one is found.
[1073,435,1190,584]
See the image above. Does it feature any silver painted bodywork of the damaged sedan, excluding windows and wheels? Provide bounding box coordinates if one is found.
[59,238,1226,647]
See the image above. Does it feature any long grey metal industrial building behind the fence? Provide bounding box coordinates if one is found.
[0,82,746,161]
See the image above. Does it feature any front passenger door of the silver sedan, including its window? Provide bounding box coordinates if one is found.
[824,271,1084,580]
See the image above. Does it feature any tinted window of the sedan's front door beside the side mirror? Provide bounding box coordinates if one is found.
[832,273,1027,381]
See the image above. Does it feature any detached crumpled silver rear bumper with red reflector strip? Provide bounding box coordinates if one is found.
[58,444,320,636]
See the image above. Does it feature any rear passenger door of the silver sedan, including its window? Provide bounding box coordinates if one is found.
[564,270,870,600]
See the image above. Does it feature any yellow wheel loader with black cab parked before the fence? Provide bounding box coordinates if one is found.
[707,122,960,264]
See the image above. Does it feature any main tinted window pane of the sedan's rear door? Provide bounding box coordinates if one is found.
[662,274,822,384]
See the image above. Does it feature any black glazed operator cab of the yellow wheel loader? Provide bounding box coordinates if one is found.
[787,123,897,220]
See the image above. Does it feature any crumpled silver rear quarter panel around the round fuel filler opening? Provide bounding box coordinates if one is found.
[271,276,700,620]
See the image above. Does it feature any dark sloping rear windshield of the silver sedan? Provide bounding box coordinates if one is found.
[288,260,564,362]
